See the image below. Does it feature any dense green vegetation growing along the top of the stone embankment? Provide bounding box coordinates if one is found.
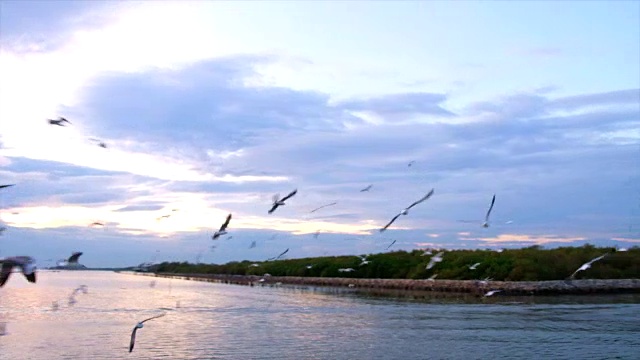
[154,245,640,281]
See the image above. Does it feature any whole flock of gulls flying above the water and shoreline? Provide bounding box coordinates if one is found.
[0,117,632,352]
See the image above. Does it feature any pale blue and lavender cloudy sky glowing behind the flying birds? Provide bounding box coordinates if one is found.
[0,0,640,267]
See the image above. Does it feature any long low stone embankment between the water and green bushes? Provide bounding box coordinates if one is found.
[126,273,640,296]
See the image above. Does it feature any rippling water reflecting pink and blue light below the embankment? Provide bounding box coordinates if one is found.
[0,271,640,360]
